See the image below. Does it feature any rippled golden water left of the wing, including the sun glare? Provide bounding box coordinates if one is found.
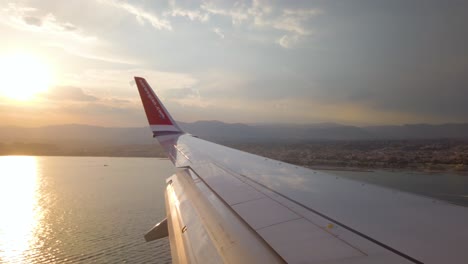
[0,156,175,263]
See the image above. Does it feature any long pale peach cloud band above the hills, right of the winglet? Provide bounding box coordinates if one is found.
[165,97,446,125]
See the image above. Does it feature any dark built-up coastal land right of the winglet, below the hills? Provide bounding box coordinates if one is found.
[230,139,468,172]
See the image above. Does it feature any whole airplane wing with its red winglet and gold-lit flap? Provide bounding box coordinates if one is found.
[135,77,468,264]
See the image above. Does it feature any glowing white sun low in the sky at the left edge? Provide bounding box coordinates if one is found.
[0,53,51,101]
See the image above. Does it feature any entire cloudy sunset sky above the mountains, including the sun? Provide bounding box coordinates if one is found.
[0,0,468,127]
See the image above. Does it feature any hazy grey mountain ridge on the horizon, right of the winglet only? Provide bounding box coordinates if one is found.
[181,121,468,141]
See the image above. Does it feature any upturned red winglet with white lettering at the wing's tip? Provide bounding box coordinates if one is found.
[135,77,183,136]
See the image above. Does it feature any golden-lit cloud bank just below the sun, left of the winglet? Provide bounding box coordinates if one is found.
[0,87,143,127]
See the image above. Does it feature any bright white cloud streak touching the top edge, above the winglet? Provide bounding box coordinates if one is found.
[100,0,172,30]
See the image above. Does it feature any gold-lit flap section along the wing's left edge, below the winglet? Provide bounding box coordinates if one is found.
[166,169,284,263]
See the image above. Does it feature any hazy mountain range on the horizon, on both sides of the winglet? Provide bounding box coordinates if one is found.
[0,121,468,145]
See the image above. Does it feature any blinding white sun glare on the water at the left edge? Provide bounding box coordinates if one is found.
[0,156,43,263]
